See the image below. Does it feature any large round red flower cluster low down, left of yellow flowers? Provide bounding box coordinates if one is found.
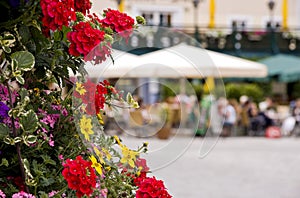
[62,156,96,197]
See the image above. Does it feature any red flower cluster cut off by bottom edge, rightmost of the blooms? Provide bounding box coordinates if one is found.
[134,174,172,198]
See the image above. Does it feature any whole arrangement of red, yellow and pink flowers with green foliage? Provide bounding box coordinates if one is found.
[0,0,171,198]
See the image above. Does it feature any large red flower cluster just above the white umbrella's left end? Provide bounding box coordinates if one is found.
[67,22,105,57]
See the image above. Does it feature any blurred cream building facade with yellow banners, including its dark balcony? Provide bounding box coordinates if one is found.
[93,0,300,57]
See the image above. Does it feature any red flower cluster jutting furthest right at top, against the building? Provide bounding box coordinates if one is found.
[100,9,134,38]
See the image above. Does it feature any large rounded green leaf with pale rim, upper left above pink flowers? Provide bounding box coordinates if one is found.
[11,51,35,71]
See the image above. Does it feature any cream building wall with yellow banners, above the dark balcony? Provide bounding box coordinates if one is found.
[93,0,300,29]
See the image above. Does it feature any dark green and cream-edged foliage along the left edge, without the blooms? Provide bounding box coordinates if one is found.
[0,1,83,197]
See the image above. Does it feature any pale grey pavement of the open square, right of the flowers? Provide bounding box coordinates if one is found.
[121,135,300,198]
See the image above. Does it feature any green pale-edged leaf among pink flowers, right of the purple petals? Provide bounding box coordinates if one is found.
[20,110,39,133]
